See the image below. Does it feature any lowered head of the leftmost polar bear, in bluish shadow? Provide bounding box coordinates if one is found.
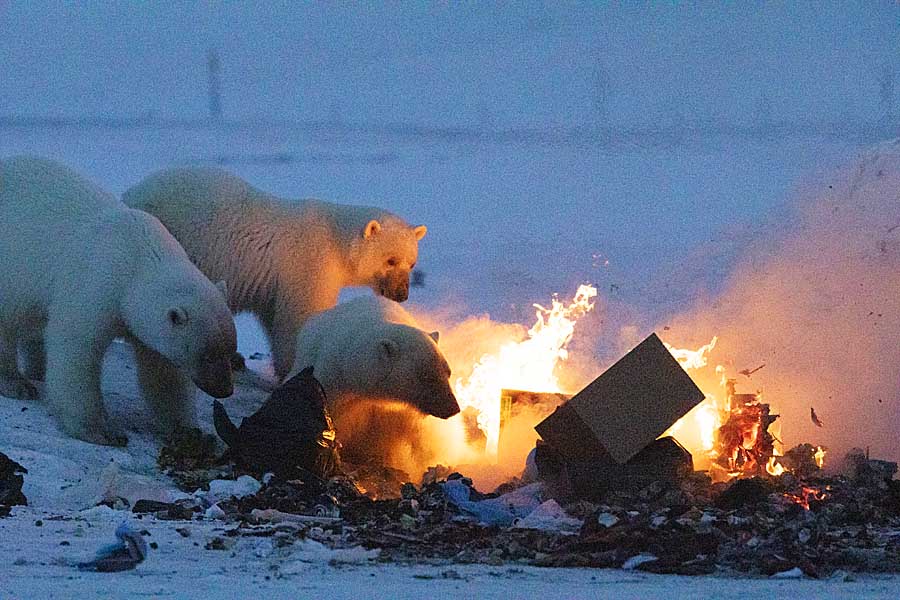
[123,272,237,398]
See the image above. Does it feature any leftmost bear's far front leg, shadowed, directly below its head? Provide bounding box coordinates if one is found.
[130,339,196,436]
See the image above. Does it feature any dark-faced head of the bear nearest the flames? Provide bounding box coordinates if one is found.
[373,323,459,419]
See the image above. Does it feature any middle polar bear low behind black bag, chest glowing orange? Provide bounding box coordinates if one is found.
[291,296,459,469]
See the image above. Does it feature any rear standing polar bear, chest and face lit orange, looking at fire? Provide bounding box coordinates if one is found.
[123,168,427,380]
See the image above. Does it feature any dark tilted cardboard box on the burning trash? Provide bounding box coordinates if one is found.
[535,333,704,464]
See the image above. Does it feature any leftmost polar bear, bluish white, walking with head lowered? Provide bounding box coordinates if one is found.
[0,157,236,444]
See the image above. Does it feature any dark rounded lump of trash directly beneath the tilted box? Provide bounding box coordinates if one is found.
[534,437,694,499]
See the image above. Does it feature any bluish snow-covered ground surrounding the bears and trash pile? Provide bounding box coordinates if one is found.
[0,128,900,598]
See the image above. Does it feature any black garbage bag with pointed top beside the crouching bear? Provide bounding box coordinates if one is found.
[213,367,339,479]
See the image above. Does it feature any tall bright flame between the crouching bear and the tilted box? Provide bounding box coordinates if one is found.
[454,285,597,456]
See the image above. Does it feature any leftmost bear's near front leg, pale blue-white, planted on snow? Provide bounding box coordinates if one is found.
[45,311,128,446]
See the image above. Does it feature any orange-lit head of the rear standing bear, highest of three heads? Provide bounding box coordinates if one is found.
[355,216,428,302]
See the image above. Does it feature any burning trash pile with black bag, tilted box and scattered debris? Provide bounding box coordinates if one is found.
[133,310,900,577]
